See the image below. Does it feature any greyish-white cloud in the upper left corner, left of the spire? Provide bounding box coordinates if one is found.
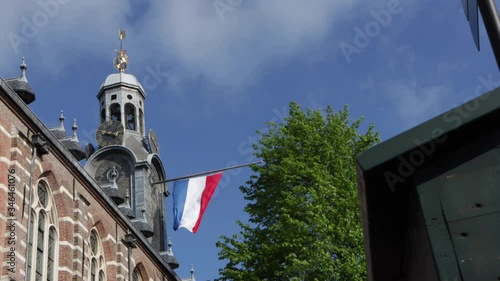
[0,0,128,75]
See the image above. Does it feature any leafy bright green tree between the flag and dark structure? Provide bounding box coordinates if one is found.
[217,103,379,281]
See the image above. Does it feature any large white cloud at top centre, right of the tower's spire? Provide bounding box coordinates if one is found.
[138,0,364,86]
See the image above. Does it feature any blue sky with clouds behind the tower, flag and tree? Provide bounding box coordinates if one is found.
[0,0,500,280]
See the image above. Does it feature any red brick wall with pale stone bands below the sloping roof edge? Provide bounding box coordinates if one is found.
[0,80,179,281]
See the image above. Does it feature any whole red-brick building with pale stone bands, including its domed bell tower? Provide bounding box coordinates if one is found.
[0,47,184,281]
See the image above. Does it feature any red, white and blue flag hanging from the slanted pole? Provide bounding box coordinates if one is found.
[172,173,222,233]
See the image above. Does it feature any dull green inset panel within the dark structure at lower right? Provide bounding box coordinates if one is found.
[417,148,500,281]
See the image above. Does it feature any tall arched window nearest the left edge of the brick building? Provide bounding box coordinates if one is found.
[26,181,58,281]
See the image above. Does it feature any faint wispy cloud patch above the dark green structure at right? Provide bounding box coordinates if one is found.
[359,46,456,129]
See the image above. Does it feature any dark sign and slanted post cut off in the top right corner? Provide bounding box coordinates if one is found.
[462,0,500,68]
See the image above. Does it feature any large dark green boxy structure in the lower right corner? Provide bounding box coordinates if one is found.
[357,88,500,281]
